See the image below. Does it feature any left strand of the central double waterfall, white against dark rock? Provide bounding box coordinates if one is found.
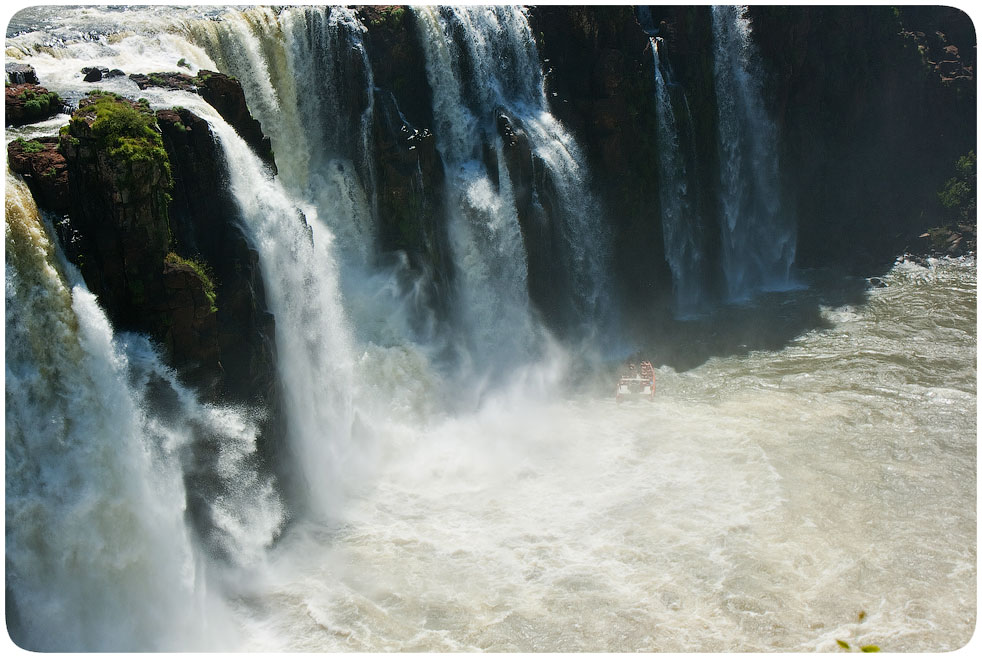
[418,7,543,376]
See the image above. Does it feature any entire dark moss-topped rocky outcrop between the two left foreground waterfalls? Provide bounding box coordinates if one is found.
[8,86,278,440]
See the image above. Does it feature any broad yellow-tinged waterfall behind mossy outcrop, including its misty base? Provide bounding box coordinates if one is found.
[185,6,446,394]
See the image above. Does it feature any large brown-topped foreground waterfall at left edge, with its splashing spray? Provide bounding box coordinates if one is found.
[5,171,283,651]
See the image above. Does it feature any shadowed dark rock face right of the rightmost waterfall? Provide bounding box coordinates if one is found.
[750,6,976,269]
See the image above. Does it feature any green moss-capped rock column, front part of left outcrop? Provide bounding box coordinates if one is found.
[61,94,221,393]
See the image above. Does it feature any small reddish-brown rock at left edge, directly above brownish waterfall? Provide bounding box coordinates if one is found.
[7,137,69,213]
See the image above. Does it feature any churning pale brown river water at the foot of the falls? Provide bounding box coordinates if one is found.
[219,260,976,651]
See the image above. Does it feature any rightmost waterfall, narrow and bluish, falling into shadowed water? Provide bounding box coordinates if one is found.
[712,6,795,300]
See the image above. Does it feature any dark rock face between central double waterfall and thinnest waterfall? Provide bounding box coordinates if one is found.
[529,6,671,305]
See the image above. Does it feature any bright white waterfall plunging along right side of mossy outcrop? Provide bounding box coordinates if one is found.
[195,107,362,516]
